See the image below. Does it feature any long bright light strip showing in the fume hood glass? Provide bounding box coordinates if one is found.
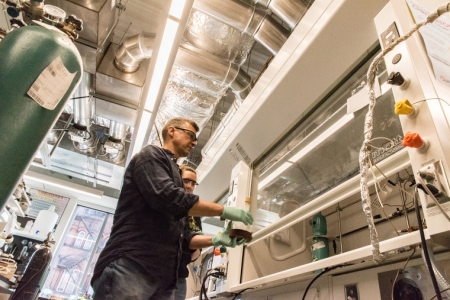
[258,113,355,190]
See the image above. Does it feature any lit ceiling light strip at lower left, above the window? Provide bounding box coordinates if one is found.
[24,171,103,198]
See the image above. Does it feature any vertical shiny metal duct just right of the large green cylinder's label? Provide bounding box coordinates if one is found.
[73,72,94,128]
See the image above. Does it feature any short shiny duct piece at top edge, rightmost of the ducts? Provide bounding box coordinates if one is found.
[254,0,313,29]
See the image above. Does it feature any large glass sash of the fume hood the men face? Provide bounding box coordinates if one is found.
[253,52,403,230]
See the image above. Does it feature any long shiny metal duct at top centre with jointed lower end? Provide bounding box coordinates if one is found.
[193,0,289,54]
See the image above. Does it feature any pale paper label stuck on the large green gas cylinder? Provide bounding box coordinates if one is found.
[27,56,77,110]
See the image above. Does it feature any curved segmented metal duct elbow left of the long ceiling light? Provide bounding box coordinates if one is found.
[114,32,156,73]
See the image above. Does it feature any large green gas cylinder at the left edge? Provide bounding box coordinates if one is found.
[0,24,83,208]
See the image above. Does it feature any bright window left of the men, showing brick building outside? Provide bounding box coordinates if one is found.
[40,206,113,299]
